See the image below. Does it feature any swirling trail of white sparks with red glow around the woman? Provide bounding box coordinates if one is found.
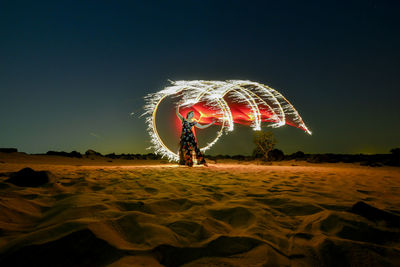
[142,80,311,161]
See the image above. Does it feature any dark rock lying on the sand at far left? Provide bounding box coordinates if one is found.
[5,168,53,187]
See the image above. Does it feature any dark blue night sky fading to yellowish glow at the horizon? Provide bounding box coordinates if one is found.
[0,0,400,154]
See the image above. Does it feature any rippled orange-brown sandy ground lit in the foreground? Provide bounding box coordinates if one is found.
[0,153,400,266]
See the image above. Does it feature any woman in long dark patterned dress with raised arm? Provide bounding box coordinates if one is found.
[176,105,215,167]
